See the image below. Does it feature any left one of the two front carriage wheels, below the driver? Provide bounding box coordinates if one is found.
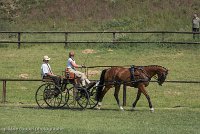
[65,87,89,109]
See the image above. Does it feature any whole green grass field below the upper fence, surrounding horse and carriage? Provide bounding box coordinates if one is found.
[0,44,200,134]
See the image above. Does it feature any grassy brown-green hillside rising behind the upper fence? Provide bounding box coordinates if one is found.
[0,0,200,31]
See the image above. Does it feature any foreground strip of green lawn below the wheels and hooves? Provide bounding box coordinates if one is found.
[0,106,200,134]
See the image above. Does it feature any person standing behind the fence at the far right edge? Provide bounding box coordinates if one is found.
[192,14,200,39]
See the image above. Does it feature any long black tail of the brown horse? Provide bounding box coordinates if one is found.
[96,69,107,101]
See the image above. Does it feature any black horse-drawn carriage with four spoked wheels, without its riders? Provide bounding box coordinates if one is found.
[35,69,98,109]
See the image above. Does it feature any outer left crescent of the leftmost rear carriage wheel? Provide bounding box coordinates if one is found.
[35,83,48,108]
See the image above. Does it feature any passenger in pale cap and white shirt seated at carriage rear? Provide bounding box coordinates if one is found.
[41,55,61,87]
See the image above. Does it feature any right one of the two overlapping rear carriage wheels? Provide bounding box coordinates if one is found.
[43,83,62,108]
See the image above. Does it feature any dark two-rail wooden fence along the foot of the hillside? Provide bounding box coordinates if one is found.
[0,31,200,48]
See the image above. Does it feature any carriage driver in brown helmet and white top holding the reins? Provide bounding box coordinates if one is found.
[67,51,95,89]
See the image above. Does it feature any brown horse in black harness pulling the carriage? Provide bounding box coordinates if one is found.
[96,65,168,112]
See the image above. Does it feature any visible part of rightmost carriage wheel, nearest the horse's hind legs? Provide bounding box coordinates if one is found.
[87,86,98,109]
